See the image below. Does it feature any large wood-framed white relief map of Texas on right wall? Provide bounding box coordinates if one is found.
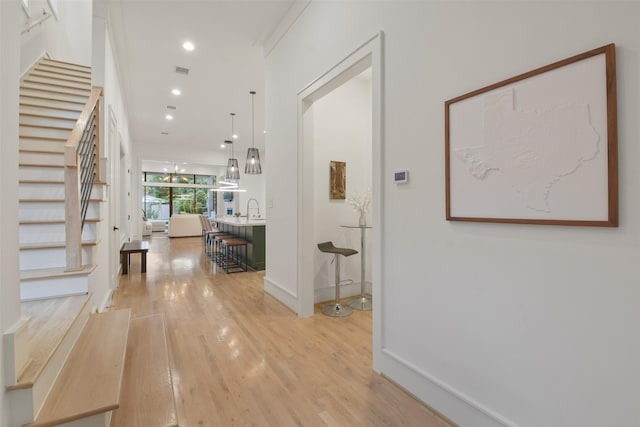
[445,44,618,227]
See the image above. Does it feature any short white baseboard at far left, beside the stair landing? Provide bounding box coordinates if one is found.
[2,318,31,386]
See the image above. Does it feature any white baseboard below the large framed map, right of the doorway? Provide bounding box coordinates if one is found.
[376,349,519,427]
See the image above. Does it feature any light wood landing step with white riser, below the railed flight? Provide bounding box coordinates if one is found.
[7,295,90,424]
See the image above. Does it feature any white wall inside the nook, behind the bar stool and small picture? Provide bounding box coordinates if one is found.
[305,72,372,302]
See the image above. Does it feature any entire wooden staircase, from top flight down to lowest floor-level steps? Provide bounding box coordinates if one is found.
[3,59,177,427]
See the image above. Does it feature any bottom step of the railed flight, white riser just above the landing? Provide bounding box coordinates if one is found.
[20,265,96,301]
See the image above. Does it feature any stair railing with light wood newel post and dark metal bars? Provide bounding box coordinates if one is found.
[64,87,102,271]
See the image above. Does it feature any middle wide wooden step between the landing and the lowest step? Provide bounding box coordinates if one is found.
[32,309,131,427]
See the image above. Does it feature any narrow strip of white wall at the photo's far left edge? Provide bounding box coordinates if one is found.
[0,0,22,426]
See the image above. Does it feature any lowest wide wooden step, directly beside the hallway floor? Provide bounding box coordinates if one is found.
[111,314,178,427]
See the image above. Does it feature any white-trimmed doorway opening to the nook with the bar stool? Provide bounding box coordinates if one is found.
[298,33,382,328]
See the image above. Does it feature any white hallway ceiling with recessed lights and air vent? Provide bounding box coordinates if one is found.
[109,0,294,167]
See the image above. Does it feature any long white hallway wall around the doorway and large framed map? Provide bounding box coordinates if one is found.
[266,1,640,427]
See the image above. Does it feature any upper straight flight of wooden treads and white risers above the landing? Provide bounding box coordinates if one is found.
[18,58,104,300]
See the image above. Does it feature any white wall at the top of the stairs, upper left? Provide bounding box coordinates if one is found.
[20,0,92,72]
